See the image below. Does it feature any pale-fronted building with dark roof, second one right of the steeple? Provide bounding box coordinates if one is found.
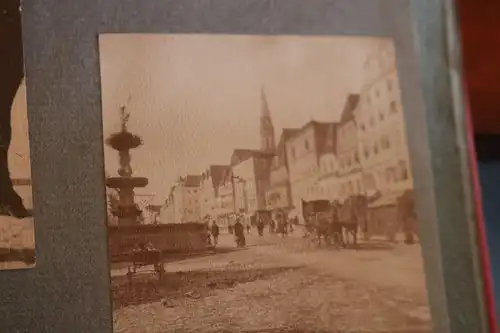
[285,121,334,222]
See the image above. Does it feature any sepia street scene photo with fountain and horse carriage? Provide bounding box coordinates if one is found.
[99,34,432,333]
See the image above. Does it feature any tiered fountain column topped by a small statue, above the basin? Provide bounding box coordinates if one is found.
[106,106,148,225]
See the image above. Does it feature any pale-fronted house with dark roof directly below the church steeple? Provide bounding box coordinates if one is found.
[231,150,274,215]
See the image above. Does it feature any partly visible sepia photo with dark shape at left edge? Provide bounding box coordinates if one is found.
[0,0,35,270]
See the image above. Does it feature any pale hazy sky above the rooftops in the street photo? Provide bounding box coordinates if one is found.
[99,34,386,203]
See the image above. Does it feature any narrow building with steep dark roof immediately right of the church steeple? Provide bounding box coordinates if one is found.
[266,128,299,211]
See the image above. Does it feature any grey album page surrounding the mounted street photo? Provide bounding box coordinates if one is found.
[0,0,489,333]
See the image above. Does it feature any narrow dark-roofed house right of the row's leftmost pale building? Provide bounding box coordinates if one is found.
[200,165,228,218]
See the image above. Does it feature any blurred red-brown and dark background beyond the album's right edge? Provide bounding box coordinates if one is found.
[458,0,500,318]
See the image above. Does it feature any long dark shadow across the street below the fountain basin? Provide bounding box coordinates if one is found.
[111,264,300,310]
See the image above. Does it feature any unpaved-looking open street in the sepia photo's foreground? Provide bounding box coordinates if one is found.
[112,230,430,333]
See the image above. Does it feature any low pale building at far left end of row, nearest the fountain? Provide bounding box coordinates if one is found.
[160,175,202,223]
